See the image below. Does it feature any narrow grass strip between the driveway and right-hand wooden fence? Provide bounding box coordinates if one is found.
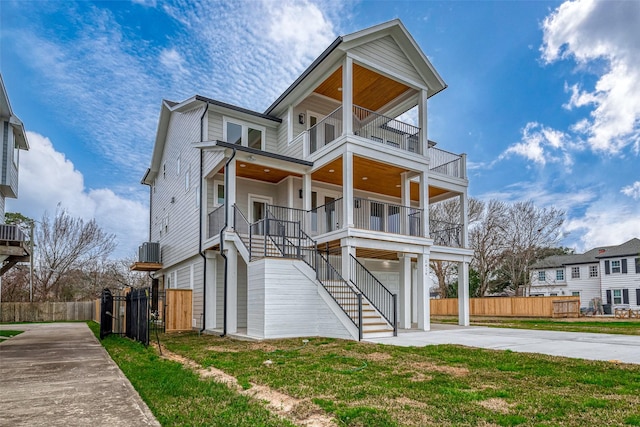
[432,316,640,335]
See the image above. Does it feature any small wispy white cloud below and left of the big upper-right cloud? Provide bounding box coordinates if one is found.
[499,122,575,167]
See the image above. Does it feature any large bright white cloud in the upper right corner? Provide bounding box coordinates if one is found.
[541,0,640,155]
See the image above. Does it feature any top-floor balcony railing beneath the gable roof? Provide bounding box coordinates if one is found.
[308,105,423,154]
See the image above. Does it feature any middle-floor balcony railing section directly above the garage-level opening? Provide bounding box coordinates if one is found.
[353,197,422,236]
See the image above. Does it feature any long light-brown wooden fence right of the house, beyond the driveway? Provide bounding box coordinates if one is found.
[430,296,580,317]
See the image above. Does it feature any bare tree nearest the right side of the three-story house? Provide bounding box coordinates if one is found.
[469,200,509,297]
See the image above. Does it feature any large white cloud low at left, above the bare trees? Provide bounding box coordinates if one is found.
[7,132,148,258]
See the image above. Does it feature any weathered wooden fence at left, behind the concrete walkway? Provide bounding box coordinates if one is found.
[0,301,95,322]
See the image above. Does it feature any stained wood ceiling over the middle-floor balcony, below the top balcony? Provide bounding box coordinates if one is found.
[311,156,447,201]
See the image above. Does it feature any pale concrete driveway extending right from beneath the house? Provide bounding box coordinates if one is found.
[368,323,640,364]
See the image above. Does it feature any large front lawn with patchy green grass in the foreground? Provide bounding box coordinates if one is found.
[94,325,640,426]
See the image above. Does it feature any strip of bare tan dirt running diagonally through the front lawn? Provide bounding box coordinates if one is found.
[156,348,336,427]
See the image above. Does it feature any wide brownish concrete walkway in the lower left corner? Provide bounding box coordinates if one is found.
[0,323,160,427]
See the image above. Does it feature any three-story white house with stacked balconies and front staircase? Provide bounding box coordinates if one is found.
[132,20,473,339]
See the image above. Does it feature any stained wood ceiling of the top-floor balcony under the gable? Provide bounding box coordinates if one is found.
[314,64,410,111]
